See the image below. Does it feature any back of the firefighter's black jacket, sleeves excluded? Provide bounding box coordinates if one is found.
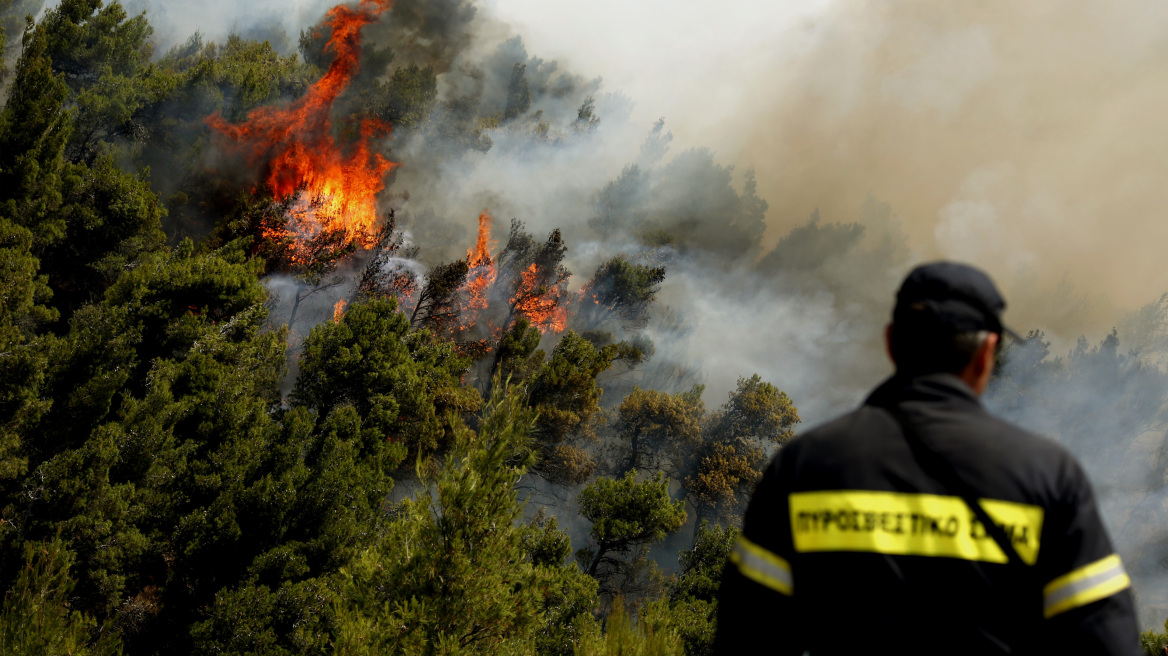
[764,377,1079,654]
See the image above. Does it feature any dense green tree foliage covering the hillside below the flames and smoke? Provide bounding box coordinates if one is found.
[0,0,798,655]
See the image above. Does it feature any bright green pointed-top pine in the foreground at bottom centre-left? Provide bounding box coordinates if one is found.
[338,385,596,655]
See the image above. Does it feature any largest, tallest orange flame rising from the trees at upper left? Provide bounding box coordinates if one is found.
[207,0,398,246]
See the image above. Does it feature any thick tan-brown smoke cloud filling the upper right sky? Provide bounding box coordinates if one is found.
[743,1,1168,333]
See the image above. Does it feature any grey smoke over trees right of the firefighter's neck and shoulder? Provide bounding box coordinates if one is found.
[986,308,1168,627]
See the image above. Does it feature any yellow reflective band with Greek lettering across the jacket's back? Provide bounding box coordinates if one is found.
[788,490,1044,565]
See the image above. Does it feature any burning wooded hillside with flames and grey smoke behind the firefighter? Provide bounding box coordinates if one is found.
[0,0,1168,655]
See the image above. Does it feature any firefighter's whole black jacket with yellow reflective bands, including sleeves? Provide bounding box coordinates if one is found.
[715,375,1142,656]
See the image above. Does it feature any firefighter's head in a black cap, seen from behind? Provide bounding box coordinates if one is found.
[887,261,1009,393]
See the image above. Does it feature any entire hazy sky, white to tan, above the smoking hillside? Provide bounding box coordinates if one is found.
[487,0,1168,326]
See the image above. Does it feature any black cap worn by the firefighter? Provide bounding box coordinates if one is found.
[892,261,1017,339]
